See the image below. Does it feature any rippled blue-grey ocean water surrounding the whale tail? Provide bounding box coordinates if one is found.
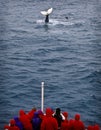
[0,0,101,130]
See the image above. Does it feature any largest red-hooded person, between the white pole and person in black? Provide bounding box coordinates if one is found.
[41,108,58,130]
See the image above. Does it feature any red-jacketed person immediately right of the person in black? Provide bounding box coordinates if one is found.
[60,112,69,130]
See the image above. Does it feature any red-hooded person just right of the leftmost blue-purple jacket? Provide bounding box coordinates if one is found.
[19,110,33,130]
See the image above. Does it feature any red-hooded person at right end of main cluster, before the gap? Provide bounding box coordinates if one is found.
[73,114,85,130]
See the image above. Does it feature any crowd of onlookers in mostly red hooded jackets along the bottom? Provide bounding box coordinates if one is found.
[4,108,100,130]
